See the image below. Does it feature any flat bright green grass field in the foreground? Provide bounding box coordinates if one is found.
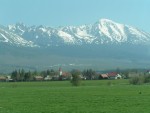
[0,80,150,113]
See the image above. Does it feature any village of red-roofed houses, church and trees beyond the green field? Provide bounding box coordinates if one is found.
[0,67,150,82]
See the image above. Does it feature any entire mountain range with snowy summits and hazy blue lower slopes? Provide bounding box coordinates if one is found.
[0,19,150,71]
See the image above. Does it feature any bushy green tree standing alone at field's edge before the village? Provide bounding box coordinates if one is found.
[71,70,81,86]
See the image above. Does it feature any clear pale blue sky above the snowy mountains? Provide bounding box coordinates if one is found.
[0,0,150,32]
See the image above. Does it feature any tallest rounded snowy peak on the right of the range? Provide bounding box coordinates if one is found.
[93,19,150,44]
